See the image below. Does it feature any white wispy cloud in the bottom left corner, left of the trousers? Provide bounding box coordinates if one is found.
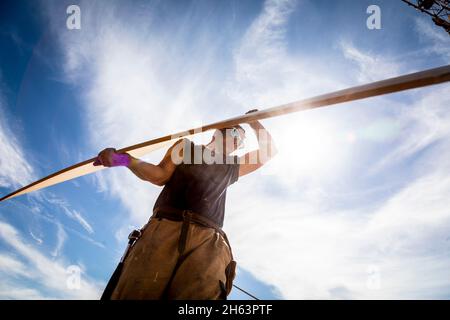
[0,222,103,299]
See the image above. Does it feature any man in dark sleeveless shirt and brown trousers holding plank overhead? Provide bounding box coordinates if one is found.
[94,110,276,300]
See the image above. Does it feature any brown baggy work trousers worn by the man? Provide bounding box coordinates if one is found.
[111,218,236,300]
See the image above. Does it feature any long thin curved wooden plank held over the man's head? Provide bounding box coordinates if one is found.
[0,65,450,202]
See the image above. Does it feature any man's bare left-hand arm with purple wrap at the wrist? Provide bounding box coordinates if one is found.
[94,140,183,186]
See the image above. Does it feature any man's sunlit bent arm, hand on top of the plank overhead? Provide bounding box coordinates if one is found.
[239,110,278,177]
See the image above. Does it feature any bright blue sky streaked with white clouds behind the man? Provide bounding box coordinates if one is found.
[0,0,450,299]
